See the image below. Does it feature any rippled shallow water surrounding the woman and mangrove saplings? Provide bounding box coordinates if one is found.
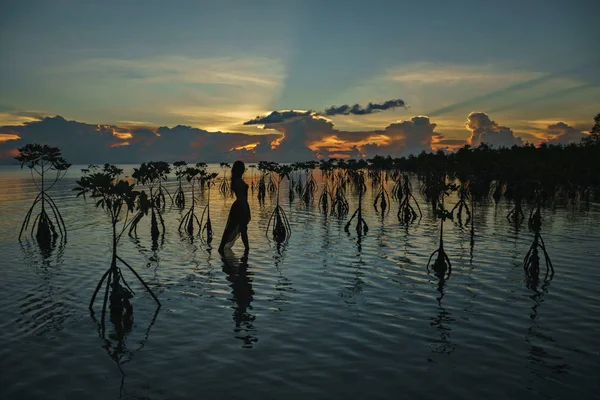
[0,167,600,399]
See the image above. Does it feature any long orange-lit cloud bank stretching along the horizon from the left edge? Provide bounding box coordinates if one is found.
[0,112,443,164]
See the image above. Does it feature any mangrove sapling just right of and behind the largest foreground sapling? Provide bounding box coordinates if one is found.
[129,161,171,240]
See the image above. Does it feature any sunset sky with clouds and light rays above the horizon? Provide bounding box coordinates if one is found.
[0,0,600,163]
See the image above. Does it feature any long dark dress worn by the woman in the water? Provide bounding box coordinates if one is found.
[221,178,250,249]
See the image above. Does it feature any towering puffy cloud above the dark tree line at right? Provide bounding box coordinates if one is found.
[465,112,523,148]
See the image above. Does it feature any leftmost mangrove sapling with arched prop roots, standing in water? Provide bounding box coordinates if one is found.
[15,144,71,243]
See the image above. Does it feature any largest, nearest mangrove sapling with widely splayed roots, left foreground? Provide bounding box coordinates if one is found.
[73,165,160,327]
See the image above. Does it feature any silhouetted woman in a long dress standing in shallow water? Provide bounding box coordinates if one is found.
[219,161,250,253]
